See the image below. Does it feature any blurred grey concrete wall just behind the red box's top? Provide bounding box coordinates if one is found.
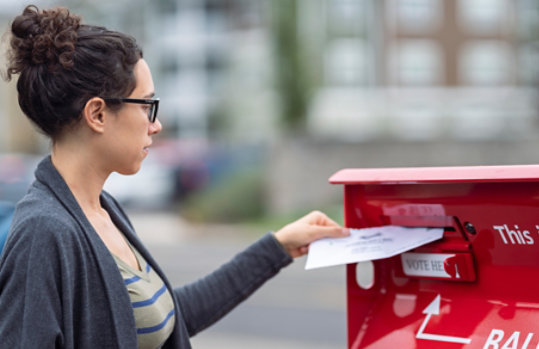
[267,139,539,213]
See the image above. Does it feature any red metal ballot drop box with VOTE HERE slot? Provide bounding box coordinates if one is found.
[330,165,539,349]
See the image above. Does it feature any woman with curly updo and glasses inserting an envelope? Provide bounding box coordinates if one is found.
[0,6,348,348]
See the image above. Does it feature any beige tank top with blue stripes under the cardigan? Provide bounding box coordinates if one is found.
[113,244,175,349]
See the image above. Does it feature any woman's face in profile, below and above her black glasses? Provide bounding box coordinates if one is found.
[105,59,162,174]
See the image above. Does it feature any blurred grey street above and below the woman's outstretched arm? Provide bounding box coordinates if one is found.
[129,212,346,349]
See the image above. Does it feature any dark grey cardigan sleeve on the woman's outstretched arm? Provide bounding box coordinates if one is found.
[174,233,292,336]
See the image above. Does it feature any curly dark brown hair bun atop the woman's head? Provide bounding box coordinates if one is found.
[8,5,81,78]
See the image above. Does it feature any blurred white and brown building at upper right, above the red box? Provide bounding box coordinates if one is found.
[306,0,539,141]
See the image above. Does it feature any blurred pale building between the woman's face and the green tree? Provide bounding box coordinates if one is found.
[145,0,276,140]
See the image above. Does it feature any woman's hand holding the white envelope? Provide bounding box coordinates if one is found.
[275,211,350,258]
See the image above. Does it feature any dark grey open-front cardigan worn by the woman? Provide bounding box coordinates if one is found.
[0,156,292,349]
